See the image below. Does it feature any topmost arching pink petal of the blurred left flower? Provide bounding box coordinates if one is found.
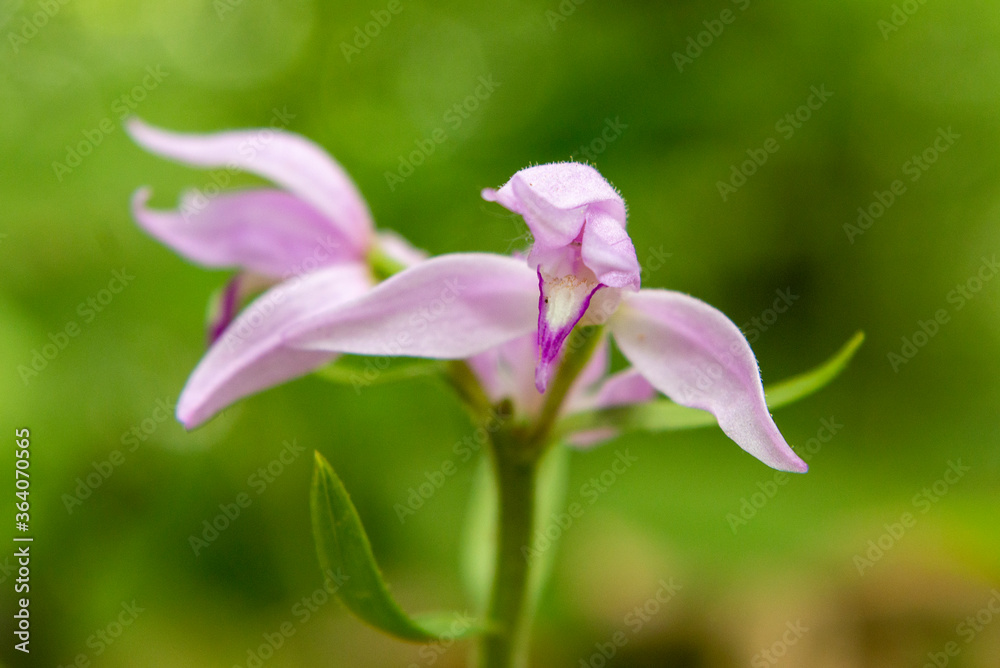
[125,117,373,254]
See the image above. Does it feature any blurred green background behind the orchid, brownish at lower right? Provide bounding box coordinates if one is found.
[0,0,1000,667]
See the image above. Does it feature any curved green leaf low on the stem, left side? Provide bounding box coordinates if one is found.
[310,452,482,643]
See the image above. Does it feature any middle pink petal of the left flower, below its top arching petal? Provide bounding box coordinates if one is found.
[132,188,359,278]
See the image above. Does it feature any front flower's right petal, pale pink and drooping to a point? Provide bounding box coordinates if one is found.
[610,290,808,473]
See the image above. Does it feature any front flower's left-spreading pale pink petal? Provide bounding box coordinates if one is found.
[286,253,538,359]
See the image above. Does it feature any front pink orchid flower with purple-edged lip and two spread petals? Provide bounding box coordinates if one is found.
[278,163,807,472]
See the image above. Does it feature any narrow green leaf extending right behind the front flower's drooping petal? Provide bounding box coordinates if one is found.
[556,332,865,437]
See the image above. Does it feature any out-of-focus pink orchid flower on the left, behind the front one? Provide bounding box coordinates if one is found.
[126,118,423,428]
